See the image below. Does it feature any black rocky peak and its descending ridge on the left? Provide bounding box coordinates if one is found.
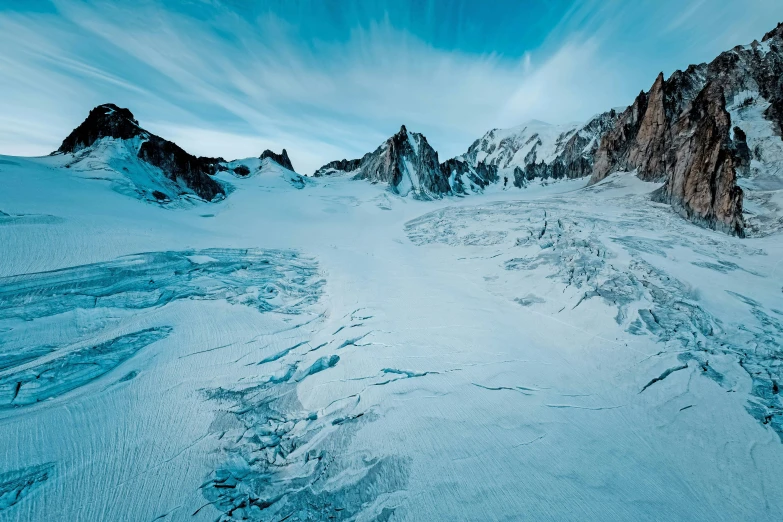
[57,104,225,201]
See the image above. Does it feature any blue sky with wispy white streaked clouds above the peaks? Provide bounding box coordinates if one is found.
[0,0,783,173]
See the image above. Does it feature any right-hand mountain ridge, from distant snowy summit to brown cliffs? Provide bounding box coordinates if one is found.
[440,24,783,235]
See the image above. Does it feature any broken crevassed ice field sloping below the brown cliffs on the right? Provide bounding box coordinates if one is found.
[406,185,783,440]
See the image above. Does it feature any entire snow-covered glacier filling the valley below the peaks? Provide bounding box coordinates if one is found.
[0,151,783,521]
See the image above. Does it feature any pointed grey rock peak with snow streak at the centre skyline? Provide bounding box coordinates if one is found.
[313,125,452,199]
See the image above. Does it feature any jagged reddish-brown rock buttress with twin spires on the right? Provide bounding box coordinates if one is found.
[590,68,749,236]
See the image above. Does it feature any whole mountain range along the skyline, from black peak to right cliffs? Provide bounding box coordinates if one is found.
[49,24,783,236]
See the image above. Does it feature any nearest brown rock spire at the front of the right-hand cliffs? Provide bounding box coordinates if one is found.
[654,82,747,236]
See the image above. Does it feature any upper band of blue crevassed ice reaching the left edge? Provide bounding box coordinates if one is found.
[0,249,320,320]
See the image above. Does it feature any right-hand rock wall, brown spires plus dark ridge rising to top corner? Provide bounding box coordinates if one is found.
[590,24,783,235]
